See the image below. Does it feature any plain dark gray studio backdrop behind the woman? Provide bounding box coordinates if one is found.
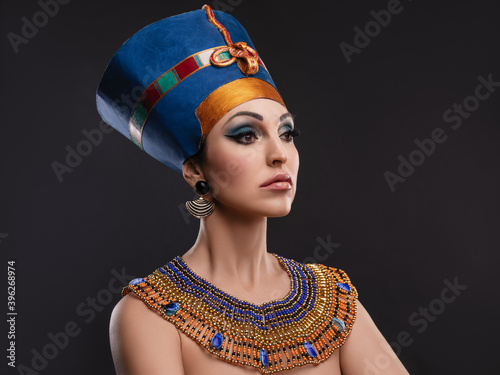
[0,0,500,374]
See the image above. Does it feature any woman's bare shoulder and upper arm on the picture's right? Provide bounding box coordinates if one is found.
[340,300,408,375]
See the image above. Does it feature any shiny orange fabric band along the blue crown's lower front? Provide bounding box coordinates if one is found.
[196,78,286,142]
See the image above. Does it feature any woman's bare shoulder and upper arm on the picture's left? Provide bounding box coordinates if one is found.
[109,293,184,375]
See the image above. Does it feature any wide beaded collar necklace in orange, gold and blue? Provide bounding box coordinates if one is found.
[122,254,358,374]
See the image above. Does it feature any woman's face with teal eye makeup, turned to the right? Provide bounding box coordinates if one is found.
[200,99,299,217]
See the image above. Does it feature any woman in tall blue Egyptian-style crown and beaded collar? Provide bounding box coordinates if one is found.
[98,6,407,374]
